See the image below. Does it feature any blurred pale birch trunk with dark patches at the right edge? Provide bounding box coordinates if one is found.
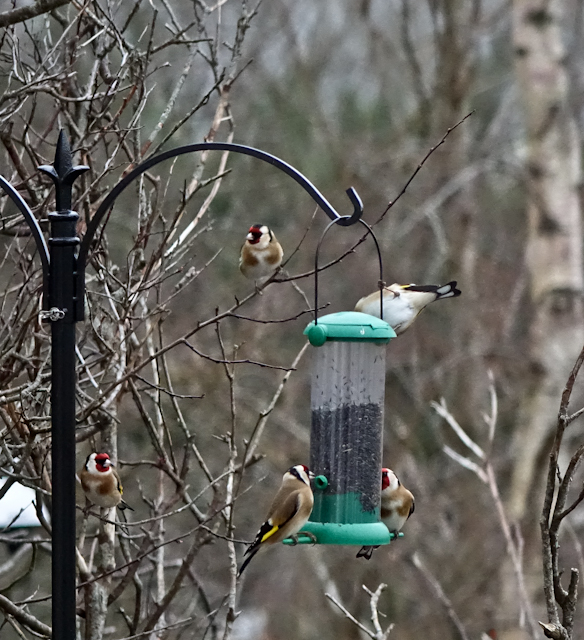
[510,0,584,518]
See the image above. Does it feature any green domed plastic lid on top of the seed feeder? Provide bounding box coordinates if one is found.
[304,311,395,347]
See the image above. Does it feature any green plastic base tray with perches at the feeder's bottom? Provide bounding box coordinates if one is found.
[282,520,404,546]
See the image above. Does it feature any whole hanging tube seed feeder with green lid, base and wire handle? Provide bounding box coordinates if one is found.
[284,219,395,545]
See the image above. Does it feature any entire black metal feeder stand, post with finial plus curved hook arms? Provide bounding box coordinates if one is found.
[0,131,363,640]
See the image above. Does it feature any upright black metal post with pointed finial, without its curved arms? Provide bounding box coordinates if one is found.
[39,131,88,640]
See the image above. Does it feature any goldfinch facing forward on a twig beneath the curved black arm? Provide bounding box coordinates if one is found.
[239,224,284,284]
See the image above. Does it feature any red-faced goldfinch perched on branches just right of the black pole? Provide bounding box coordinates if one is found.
[79,453,133,511]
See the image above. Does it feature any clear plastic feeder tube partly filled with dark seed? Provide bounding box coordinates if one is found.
[310,340,386,523]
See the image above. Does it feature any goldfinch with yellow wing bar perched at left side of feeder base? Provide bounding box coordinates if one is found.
[237,464,314,576]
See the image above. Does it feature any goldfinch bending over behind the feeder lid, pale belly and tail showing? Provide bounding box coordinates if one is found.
[355,280,461,336]
